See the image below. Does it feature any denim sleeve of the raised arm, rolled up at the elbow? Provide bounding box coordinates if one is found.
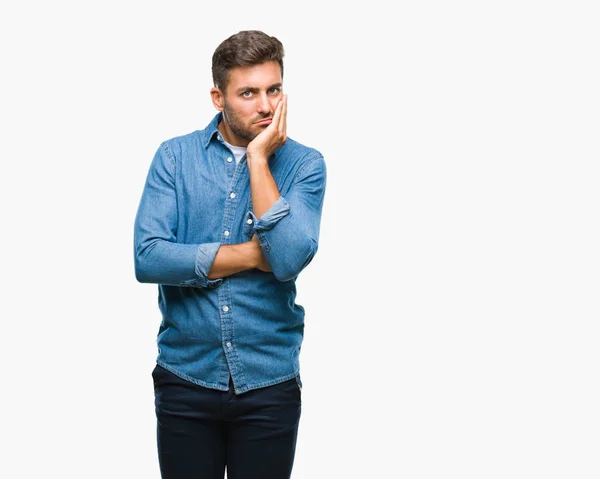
[251,156,327,281]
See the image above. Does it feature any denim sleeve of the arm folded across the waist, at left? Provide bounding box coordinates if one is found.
[134,143,223,288]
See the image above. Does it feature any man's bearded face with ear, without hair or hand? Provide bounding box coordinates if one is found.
[211,61,282,146]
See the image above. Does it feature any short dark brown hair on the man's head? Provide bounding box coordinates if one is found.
[212,30,283,93]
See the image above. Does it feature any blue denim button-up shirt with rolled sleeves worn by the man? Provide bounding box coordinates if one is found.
[134,113,326,394]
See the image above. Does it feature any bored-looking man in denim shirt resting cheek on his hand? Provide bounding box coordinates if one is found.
[134,31,326,479]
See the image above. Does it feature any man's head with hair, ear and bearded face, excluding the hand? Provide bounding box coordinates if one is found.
[211,30,283,146]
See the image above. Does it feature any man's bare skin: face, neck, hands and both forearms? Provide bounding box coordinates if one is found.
[208,61,287,279]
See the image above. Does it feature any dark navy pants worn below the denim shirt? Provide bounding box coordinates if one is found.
[152,365,301,479]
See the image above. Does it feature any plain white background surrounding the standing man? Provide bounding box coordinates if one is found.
[0,0,600,479]
